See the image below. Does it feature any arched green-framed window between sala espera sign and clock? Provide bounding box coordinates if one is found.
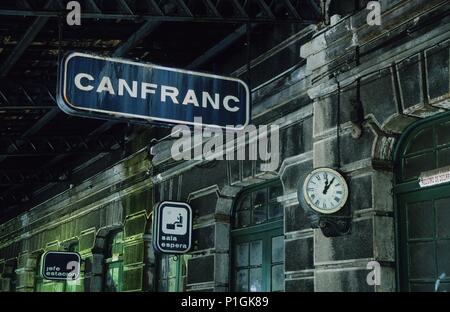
[231,180,284,292]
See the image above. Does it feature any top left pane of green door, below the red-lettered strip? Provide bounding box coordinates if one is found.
[407,201,434,239]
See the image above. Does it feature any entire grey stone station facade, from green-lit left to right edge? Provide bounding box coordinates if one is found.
[0,0,450,292]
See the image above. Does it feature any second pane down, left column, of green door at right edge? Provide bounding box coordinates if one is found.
[408,242,435,278]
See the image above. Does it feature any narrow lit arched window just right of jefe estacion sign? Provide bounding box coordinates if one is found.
[105,231,123,292]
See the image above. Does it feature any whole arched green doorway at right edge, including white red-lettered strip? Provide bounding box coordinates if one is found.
[394,115,450,292]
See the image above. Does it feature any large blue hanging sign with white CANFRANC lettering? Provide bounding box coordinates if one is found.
[57,52,250,129]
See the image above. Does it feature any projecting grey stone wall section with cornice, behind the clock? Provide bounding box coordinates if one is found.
[301,1,449,291]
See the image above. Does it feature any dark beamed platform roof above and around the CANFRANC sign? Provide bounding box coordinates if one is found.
[0,0,321,220]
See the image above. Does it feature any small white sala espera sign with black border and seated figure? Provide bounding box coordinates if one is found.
[153,201,192,254]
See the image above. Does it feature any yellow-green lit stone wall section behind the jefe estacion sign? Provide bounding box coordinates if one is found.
[0,150,154,291]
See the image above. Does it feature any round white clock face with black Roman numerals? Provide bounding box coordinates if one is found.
[303,168,348,214]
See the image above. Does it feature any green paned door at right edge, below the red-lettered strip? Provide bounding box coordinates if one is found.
[398,185,450,291]
